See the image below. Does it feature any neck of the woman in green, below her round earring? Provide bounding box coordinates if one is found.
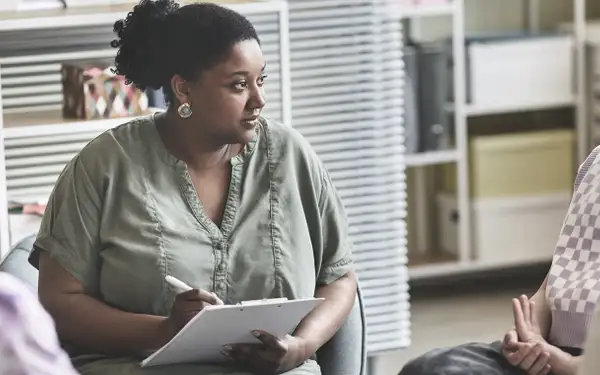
[157,111,240,171]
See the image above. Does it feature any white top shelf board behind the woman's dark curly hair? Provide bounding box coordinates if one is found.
[0,0,283,32]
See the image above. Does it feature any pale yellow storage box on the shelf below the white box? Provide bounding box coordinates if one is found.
[442,130,577,198]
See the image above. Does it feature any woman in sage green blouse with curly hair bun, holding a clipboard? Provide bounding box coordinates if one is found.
[31,0,356,375]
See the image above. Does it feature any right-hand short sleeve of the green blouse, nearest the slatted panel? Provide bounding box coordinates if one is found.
[317,170,353,285]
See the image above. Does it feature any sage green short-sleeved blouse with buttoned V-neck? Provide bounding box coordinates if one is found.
[30,116,352,375]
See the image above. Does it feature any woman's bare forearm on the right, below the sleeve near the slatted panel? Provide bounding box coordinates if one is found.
[294,272,357,358]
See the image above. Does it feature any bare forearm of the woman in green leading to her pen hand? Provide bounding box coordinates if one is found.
[38,251,171,354]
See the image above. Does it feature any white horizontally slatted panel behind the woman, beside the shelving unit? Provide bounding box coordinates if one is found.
[288,0,410,354]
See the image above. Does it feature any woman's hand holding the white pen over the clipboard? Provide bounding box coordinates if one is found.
[165,289,223,340]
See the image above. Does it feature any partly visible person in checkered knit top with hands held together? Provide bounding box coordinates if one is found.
[400,147,600,375]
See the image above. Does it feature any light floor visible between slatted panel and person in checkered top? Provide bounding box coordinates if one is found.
[373,274,535,375]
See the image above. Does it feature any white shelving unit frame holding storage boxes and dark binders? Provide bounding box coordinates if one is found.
[397,0,591,279]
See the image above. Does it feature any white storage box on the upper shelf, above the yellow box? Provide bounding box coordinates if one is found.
[467,35,575,107]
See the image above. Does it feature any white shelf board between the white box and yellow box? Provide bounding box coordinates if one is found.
[446,97,577,117]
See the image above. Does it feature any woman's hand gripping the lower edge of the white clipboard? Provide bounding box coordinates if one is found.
[223,331,310,374]
